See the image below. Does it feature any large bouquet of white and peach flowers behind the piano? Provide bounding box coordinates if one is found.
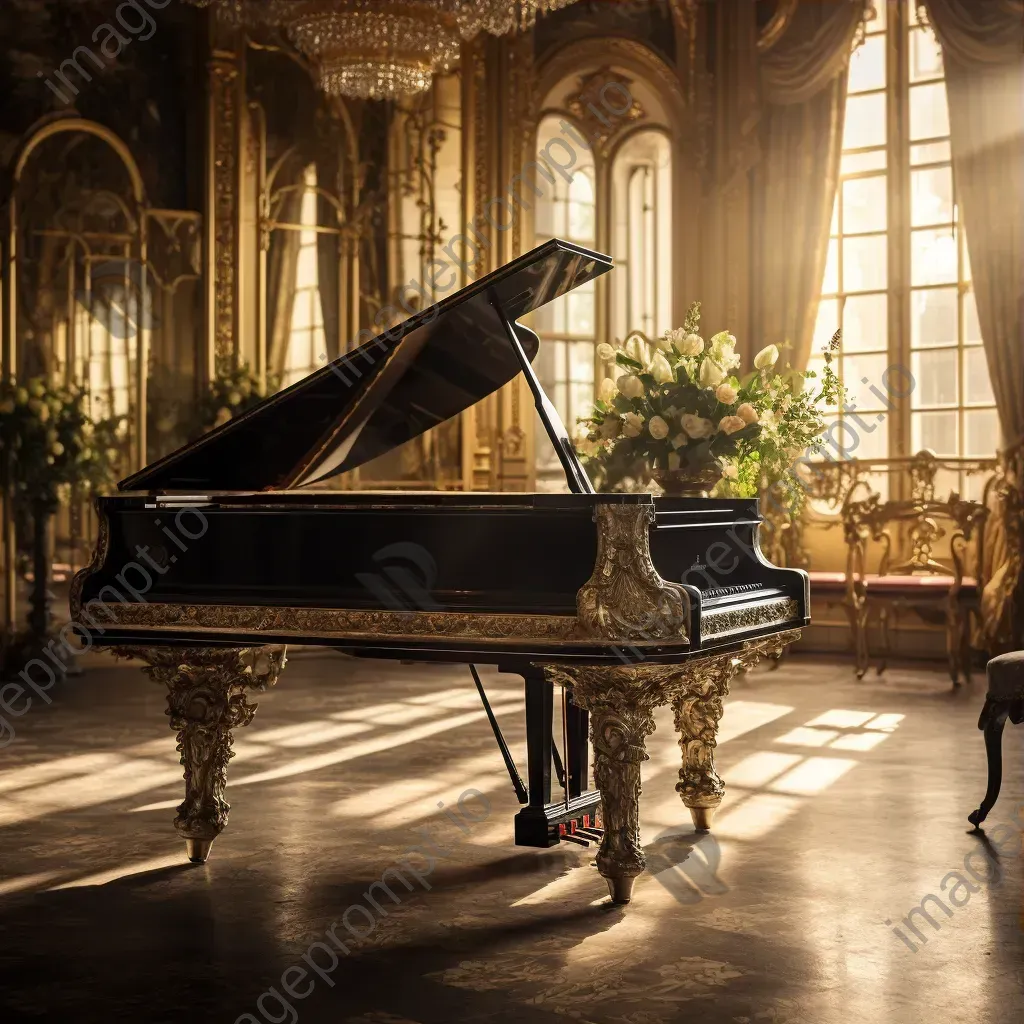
[577,302,843,506]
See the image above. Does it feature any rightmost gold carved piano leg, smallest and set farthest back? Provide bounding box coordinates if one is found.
[672,679,729,831]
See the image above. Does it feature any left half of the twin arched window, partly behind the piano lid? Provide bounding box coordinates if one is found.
[534,117,597,489]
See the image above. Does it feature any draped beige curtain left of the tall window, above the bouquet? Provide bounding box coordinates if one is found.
[755,0,865,369]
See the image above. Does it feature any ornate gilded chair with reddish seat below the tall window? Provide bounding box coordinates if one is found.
[843,494,988,686]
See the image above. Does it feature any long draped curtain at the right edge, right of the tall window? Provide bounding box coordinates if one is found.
[925,0,1024,651]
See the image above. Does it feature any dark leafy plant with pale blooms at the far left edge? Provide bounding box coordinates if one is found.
[0,377,123,514]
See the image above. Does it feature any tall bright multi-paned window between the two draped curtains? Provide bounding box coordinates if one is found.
[811,0,998,485]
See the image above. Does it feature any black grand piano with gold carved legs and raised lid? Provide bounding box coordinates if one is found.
[71,240,809,902]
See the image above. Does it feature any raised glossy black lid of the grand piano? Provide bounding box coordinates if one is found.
[118,239,612,494]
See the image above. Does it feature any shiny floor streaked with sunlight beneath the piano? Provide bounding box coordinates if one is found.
[0,653,1024,1024]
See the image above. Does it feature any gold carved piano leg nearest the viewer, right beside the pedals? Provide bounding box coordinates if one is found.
[549,667,658,903]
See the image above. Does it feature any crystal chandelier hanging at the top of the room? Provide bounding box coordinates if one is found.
[188,0,573,99]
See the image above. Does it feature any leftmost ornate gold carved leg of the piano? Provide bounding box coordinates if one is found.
[128,647,286,864]
